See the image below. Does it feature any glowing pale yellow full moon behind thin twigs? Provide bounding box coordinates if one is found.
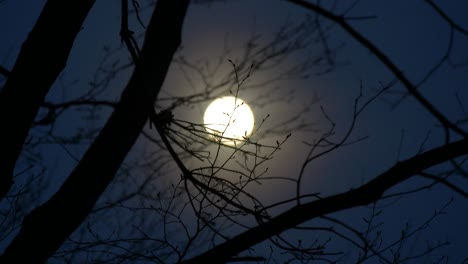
[203,96,254,143]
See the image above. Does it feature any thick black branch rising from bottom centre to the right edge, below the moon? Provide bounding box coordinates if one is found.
[184,139,468,263]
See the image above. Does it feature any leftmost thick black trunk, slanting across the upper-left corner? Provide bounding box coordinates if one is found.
[0,0,94,198]
